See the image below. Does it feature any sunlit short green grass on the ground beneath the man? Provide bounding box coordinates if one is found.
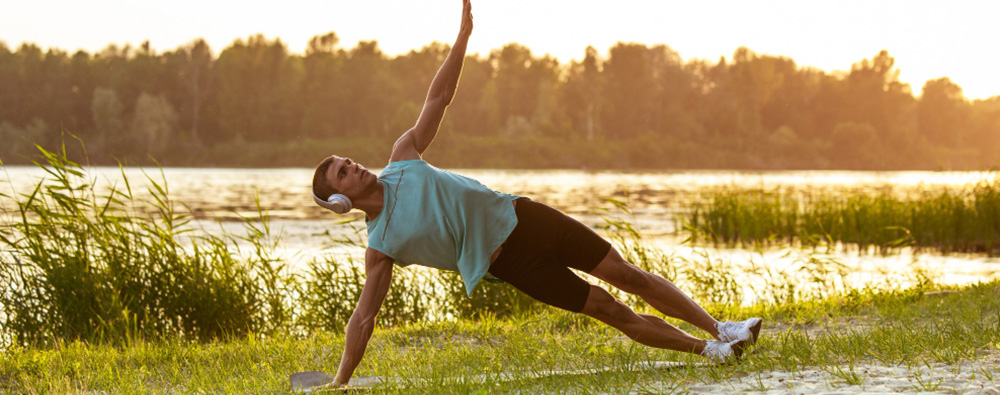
[0,282,1000,393]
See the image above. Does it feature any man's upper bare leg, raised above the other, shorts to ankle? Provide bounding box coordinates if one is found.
[588,248,719,338]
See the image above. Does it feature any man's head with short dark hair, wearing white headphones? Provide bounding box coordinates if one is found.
[313,155,378,213]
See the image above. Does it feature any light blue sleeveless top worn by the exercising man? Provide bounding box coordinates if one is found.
[368,159,518,295]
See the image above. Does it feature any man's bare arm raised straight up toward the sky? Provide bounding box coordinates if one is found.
[389,0,472,162]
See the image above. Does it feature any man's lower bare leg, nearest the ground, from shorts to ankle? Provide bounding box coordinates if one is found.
[580,285,707,354]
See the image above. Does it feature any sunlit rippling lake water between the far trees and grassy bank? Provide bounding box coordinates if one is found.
[0,166,1000,298]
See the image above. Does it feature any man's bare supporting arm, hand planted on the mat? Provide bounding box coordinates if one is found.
[337,248,393,385]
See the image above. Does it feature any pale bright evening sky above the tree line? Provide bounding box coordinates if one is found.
[0,0,1000,99]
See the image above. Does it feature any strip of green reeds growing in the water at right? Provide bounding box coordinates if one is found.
[682,177,1000,255]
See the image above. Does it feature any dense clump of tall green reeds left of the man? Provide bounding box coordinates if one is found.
[0,148,291,345]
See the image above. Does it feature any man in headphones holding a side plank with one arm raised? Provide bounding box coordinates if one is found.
[313,0,761,385]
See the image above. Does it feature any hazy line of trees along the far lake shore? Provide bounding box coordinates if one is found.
[0,33,1000,169]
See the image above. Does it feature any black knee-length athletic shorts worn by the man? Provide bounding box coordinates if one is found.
[489,198,611,312]
